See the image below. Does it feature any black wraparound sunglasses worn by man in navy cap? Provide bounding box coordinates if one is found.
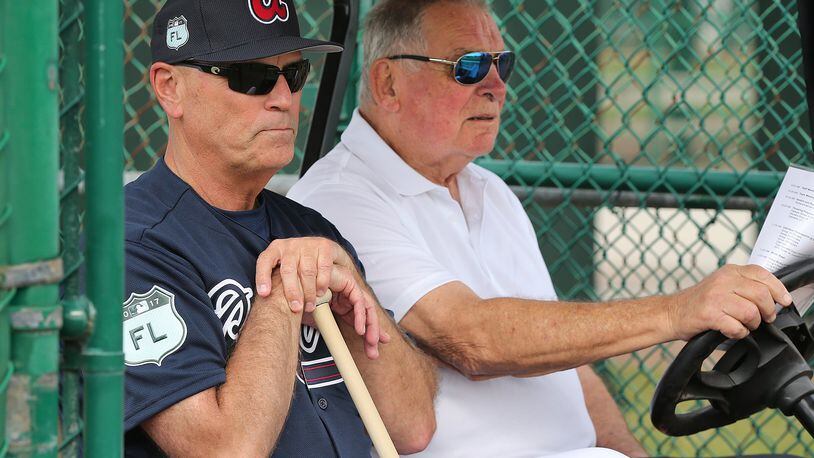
[178,59,311,95]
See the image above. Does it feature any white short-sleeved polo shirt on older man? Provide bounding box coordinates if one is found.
[288,110,599,457]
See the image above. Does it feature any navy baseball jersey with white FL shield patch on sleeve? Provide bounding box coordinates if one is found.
[122,160,371,456]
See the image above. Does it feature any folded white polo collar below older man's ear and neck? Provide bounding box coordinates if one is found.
[342,108,446,196]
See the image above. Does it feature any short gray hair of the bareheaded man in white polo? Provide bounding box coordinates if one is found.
[359,0,489,104]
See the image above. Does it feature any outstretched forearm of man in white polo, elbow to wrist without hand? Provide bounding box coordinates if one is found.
[401,283,674,378]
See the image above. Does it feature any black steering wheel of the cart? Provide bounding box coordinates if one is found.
[650,259,814,436]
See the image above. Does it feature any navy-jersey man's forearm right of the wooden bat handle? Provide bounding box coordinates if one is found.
[340,307,437,454]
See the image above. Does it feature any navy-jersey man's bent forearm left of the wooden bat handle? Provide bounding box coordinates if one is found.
[142,274,301,456]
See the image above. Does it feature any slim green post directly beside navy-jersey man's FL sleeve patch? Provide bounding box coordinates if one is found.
[83,0,124,457]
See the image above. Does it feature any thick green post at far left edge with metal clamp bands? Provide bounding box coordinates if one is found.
[0,0,62,456]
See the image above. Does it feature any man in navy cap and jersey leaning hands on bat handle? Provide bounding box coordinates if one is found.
[122,0,436,456]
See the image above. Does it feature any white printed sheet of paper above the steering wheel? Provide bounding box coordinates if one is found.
[749,166,814,315]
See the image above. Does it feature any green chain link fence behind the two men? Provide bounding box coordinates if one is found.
[52,0,814,456]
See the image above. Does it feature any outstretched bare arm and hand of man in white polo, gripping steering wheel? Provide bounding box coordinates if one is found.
[408,265,791,377]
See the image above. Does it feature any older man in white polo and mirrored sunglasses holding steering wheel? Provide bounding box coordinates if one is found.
[289,0,790,456]
